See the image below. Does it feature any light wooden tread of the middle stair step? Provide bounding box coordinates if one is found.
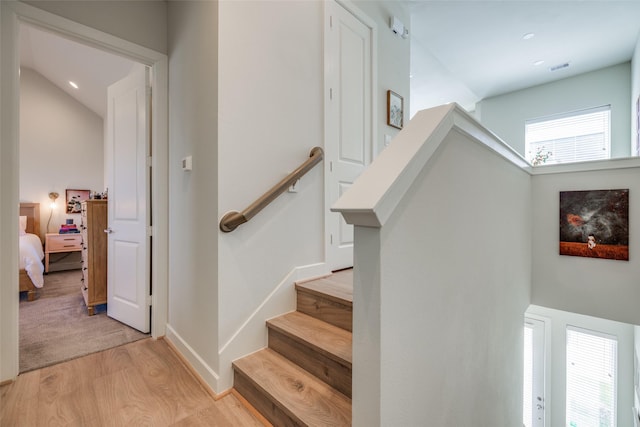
[267,311,352,368]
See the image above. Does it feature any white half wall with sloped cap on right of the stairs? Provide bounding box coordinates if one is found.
[334,106,531,426]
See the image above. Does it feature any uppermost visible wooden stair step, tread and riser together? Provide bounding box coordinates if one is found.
[296,270,353,331]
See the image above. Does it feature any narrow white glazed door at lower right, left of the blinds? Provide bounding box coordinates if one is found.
[523,318,545,427]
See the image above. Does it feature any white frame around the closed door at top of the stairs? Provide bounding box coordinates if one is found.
[323,0,378,270]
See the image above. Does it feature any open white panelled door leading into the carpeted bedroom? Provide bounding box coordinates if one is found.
[105,67,151,332]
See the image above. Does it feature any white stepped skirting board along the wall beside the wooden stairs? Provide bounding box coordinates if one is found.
[216,263,331,390]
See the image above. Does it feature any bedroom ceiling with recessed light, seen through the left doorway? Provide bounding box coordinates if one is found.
[20,24,135,118]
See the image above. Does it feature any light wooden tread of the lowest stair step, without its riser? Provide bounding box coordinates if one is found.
[233,348,351,426]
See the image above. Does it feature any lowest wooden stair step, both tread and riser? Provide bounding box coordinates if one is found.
[233,348,351,426]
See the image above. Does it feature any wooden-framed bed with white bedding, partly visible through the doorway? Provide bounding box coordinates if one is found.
[18,203,44,301]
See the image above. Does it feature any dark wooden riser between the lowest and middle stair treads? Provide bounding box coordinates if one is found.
[269,328,352,397]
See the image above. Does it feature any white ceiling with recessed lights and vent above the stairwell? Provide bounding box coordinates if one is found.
[407,0,640,114]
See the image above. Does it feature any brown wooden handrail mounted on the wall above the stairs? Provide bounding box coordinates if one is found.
[220,147,324,233]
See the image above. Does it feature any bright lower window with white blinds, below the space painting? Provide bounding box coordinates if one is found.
[567,326,618,427]
